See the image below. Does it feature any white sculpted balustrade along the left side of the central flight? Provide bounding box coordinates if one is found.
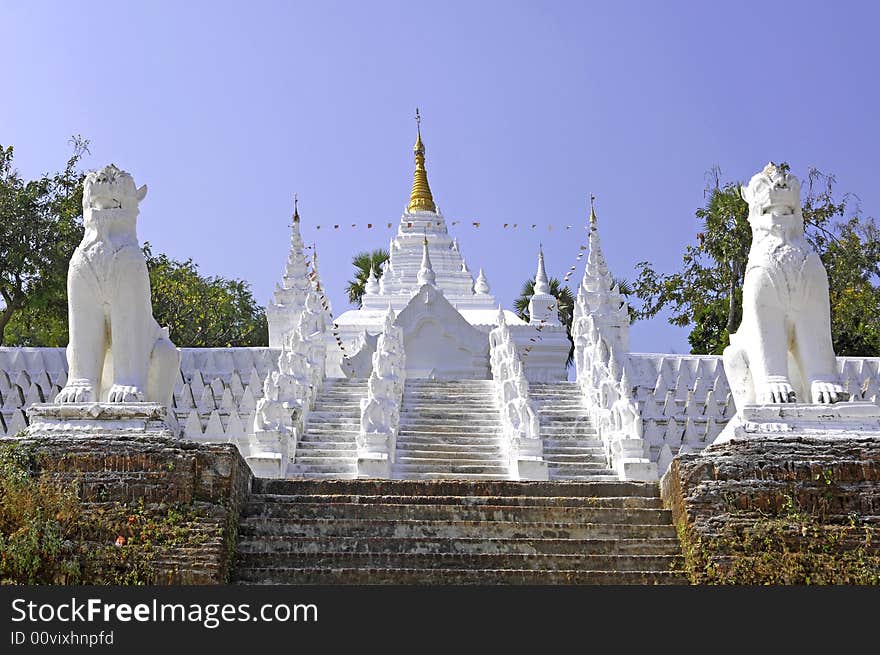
[357,307,406,478]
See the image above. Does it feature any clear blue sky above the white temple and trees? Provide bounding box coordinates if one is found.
[0,0,880,352]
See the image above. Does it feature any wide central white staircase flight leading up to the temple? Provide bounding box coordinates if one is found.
[392,379,509,480]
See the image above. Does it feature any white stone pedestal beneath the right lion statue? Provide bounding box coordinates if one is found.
[713,402,880,445]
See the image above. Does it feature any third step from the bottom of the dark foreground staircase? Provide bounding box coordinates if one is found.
[238,535,681,555]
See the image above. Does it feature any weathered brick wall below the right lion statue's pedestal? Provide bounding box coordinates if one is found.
[661,437,880,584]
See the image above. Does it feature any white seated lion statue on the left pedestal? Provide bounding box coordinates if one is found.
[55,164,180,406]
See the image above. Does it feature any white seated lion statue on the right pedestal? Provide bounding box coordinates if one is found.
[724,162,849,409]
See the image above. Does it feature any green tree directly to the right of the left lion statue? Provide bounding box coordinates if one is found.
[144,243,269,348]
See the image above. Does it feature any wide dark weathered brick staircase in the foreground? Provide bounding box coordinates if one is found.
[233,480,687,584]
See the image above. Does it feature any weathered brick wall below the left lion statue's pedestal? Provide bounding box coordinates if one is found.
[0,436,251,584]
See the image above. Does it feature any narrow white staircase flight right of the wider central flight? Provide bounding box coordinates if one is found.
[529,382,617,481]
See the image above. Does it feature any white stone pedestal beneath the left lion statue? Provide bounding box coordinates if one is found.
[26,403,174,438]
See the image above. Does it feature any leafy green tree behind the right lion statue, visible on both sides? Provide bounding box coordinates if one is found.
[633,165,880,356]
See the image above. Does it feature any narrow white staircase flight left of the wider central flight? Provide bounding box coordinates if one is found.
[287,379,367,479]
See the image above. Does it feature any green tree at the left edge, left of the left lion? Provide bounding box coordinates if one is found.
[0,137,88,346]
